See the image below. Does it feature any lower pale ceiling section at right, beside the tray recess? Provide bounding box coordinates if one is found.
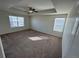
[52,0,78,13]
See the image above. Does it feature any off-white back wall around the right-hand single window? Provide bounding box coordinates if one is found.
[31,15,67,37]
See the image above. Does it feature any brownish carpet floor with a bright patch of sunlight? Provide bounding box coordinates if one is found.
[1,30,62,58]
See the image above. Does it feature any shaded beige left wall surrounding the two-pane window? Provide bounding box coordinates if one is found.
[0,11,29,34]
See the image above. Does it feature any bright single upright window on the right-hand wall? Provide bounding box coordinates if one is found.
[53,18,65,32]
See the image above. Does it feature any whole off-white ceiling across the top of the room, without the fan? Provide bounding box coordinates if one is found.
[0,0,78,14]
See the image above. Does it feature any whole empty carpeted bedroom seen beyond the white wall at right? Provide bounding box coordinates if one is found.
[0,0,78,58]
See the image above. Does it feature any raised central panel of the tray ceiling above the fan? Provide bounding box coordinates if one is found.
[13,0,54,10]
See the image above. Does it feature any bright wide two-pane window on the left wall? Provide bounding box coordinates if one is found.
[9,16,24,28]
